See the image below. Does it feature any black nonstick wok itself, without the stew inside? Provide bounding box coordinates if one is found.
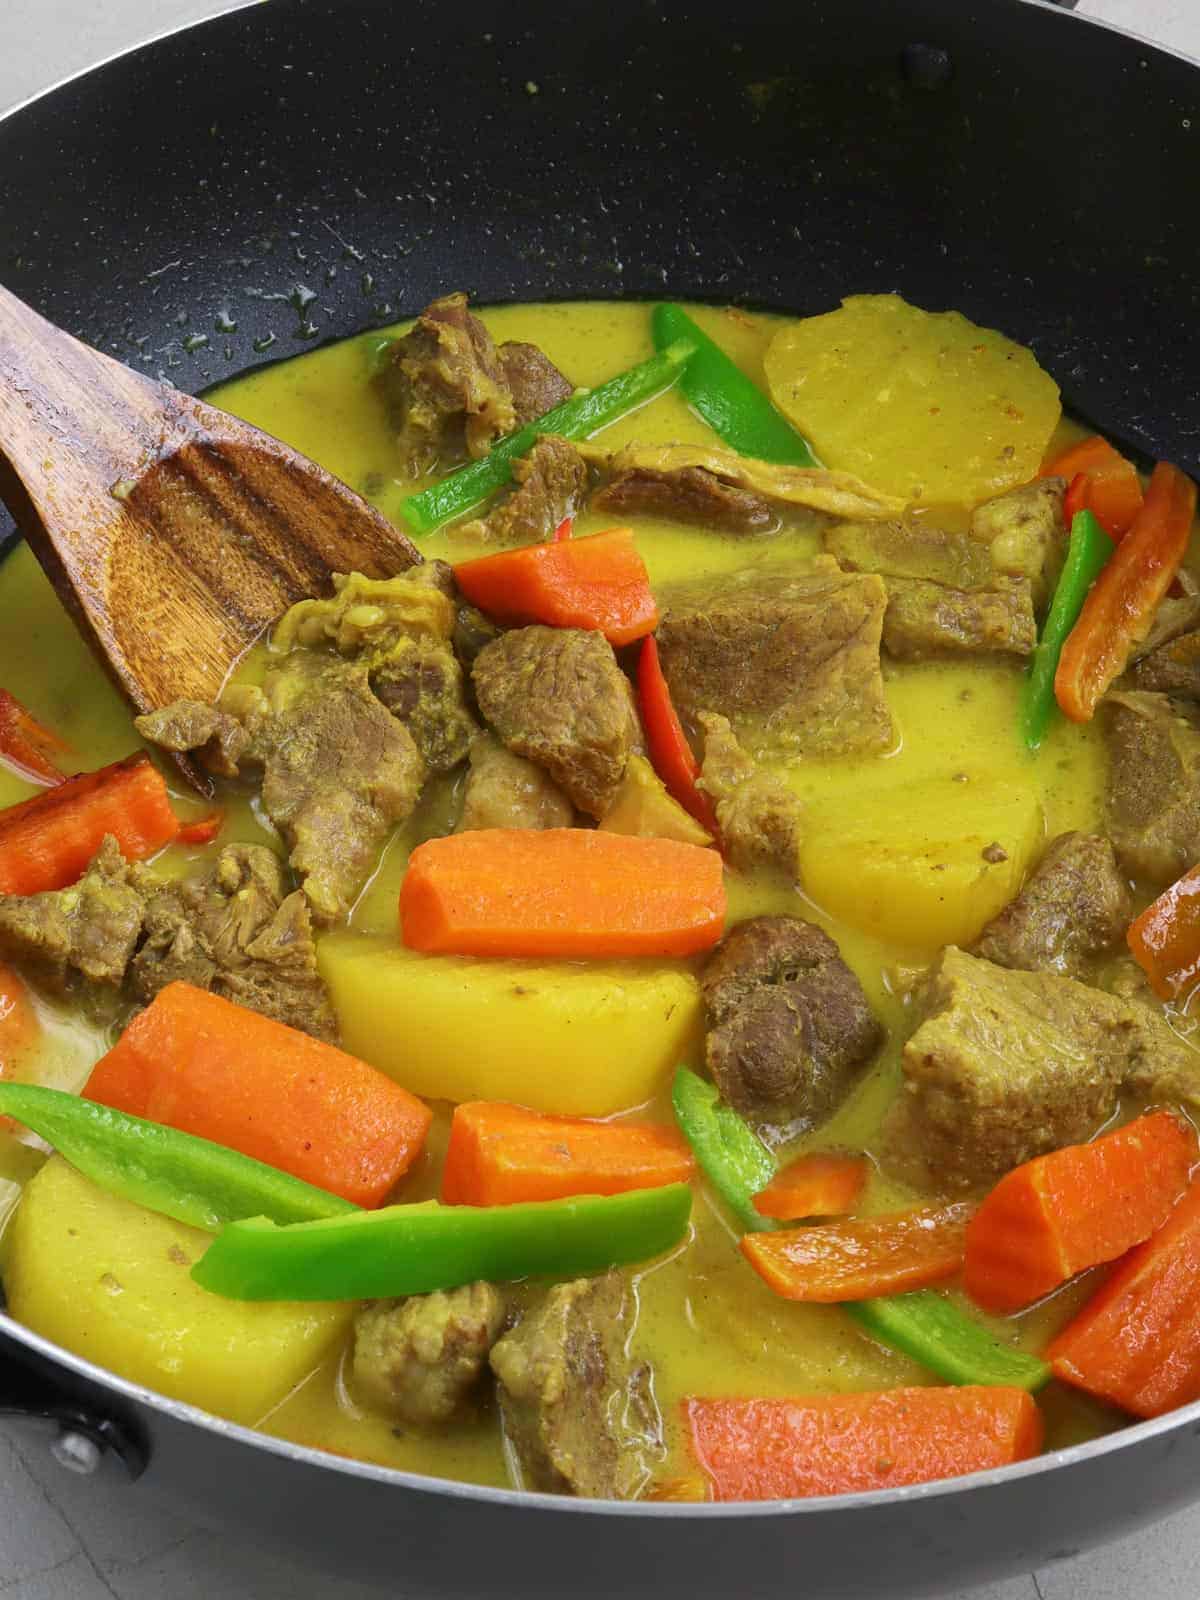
[0,0,1200,1600]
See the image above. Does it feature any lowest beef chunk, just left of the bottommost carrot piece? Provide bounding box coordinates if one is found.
[491,1272,662,1499]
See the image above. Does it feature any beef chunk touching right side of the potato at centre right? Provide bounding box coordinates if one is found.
[976,834,1131,978]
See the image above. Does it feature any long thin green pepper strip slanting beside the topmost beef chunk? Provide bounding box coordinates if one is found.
[400,339,696,533]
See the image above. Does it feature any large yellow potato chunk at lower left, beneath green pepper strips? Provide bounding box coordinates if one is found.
[5,1155,354,1424]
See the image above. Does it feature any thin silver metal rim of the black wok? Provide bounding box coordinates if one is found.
[0,0,1200,1522]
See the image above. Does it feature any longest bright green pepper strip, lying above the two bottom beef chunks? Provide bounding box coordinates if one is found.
[192,1184,691,1301]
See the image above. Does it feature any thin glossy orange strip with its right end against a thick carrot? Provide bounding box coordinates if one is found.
[741,1200,973,1302]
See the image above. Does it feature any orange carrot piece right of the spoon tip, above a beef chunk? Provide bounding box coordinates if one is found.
[454,528,658,645]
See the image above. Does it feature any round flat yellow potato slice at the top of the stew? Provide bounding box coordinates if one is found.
[763,294,1061,506]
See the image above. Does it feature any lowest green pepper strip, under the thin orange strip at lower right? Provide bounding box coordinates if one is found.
[842,1290,1051,1394]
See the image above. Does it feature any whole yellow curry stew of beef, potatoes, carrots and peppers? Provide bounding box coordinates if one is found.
[0,294,1200,1501]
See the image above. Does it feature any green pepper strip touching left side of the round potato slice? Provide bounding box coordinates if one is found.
[651,304,821,467]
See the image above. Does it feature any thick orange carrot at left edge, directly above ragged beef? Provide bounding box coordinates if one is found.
[0,752,179,894]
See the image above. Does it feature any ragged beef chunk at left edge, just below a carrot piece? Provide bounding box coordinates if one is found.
[0,834,142,994]
